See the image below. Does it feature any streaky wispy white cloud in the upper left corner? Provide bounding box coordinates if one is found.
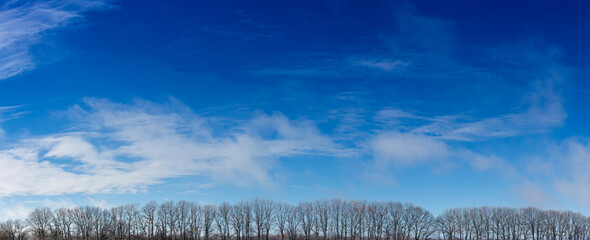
[0,0,107,80]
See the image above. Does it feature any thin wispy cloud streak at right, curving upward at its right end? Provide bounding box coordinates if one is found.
[375,72,567,141]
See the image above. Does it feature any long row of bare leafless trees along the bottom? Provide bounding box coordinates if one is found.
[0,198,590,240]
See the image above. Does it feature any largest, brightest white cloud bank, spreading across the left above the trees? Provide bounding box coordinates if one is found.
[0,99,345,196]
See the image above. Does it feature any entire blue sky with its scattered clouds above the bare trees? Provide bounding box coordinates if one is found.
[0,0,590,218]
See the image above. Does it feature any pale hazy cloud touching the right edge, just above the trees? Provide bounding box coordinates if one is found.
[490,137,590,209]
